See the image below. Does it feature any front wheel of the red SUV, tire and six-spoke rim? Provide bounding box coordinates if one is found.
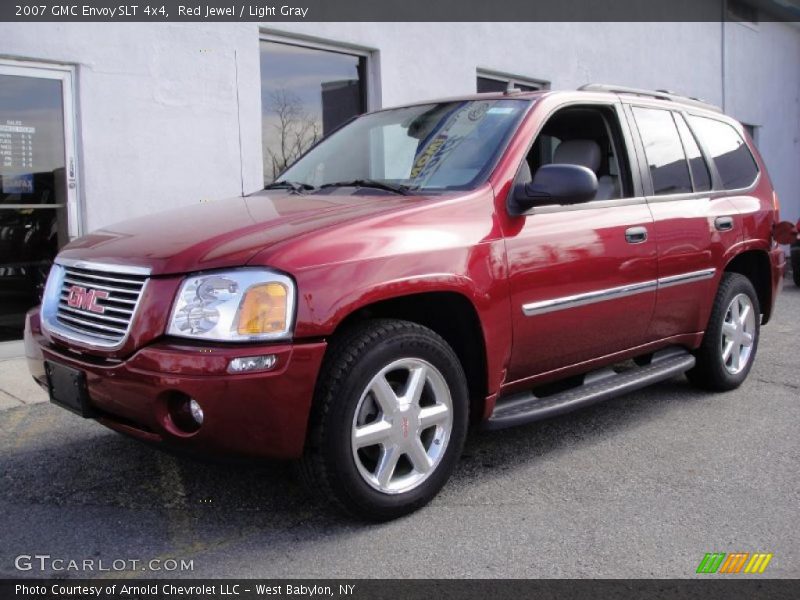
[301,319,469,520]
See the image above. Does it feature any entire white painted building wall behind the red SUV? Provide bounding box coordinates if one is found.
[0,23,800,230]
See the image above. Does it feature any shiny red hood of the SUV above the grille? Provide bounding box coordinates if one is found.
[59,190,424,275]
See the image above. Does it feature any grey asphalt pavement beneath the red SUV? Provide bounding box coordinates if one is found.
[0,282,800,578]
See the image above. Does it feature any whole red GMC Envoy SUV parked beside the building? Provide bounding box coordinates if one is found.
[25,85,785,520]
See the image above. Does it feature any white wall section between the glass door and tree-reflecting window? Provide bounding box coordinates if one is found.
[0,23,262,231]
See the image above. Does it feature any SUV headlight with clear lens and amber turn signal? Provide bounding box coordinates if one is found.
[167,269,295,342]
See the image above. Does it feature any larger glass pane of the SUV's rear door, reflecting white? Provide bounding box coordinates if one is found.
[633,107,692,195]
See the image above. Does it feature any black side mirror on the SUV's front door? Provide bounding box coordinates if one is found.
[508,164,597,216]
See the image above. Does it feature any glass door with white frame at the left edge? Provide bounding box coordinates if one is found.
[0,63,78,342]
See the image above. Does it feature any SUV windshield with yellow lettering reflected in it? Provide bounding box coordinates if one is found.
[277,99,530,191]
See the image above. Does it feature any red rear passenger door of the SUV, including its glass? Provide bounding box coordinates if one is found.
[626,105,742,340]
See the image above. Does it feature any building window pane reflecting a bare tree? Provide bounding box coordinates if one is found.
[261,41,367,183]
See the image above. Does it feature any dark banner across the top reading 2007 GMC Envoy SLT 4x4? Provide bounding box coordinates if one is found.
[0,0,800,24]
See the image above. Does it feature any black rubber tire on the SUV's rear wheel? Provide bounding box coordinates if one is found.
[686,273,761,391]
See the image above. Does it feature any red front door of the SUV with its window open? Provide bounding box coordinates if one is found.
[506,104,657,382]
